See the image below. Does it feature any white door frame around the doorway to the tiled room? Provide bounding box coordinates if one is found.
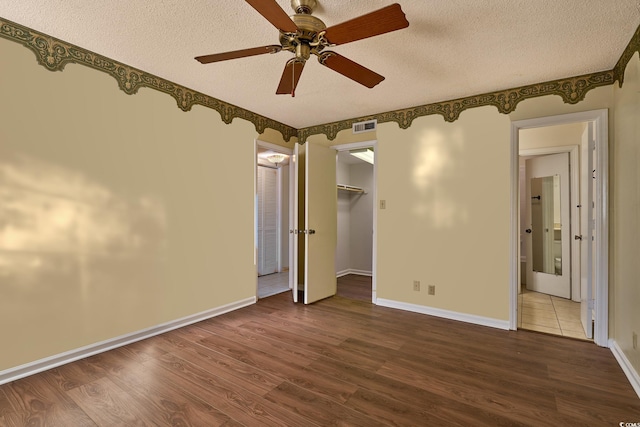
[509,109,609,347]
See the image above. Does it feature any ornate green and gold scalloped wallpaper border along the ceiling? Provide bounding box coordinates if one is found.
[0,18,640,142]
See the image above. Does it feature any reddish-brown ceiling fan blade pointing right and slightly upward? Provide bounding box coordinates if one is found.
[324,3,409,44]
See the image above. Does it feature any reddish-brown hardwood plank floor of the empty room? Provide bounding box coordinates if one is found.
[0,276,640,427]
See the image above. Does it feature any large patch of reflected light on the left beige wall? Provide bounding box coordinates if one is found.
[0,155,167,302]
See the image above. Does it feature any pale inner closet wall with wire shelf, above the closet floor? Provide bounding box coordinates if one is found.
[336,154,374,276]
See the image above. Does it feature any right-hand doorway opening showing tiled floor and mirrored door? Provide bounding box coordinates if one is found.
[517,146,592,340]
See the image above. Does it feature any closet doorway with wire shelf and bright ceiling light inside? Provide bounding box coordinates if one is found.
[333,141,376,304]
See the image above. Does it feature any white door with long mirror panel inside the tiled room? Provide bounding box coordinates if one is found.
[526,153,571,298]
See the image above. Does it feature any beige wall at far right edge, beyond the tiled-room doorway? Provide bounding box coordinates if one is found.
[609,53,640,373]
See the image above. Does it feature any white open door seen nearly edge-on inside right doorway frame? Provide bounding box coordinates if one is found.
[579,122,595,338]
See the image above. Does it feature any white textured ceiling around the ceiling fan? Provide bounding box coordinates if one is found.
[0,0,640,128]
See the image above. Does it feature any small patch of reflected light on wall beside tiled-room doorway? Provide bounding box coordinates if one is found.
[412,130,469,228]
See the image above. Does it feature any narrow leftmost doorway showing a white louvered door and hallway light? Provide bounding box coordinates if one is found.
[255,141,291,298]
